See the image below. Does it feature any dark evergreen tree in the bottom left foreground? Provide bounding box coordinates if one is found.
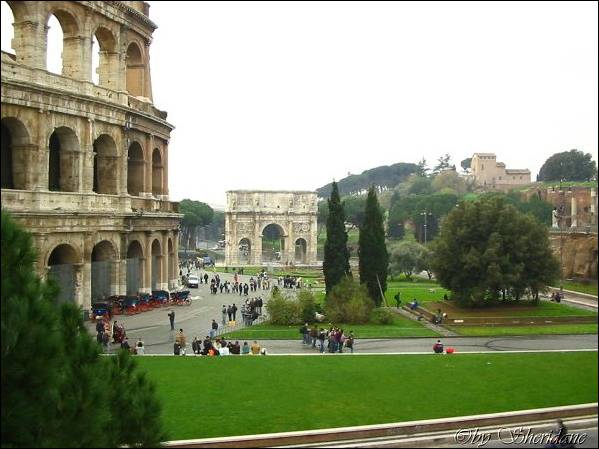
[0,212,165,447]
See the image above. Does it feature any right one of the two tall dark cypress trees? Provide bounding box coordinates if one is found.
[359,186,389,306]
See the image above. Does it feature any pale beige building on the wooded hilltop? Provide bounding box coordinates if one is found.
[470,153,531,190]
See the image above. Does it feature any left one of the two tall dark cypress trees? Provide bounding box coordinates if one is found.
[322,182,351,295]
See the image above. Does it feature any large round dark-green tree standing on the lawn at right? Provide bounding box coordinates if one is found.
[432,196,559,304]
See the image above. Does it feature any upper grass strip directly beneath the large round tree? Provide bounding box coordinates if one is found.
[424,301,597,319]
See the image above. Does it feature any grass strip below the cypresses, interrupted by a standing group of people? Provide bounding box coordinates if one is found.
[225,316,437,340]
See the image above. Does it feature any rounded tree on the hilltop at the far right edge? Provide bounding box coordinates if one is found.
[537,150,597,182]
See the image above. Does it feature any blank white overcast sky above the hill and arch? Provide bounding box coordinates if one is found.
[3,1,599,205]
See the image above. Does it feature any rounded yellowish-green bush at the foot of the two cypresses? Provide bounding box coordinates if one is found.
[325,277,374,324]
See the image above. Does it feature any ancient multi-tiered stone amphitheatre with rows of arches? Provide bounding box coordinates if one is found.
[0,1,181,312]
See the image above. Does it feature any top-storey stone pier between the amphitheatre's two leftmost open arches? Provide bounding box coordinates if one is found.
[11,17,48,69]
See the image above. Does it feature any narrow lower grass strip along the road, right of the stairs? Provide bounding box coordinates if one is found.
[448,324,597,337]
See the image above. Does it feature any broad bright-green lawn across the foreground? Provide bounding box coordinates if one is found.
[137,352,597,440]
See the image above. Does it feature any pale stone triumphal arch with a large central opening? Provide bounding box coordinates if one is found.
[225,190,318,266]
